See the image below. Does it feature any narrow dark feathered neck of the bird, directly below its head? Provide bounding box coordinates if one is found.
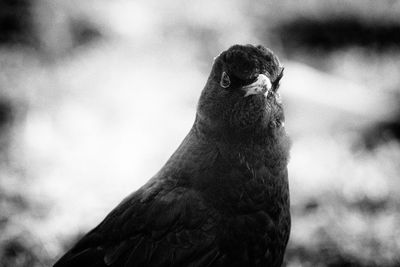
[163,120,290,180]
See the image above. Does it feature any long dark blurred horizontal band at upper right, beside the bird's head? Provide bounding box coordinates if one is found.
[273,16,400,56]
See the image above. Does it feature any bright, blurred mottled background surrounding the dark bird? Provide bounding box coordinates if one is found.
[0,0,400,267]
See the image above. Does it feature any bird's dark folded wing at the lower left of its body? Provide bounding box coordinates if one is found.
[55,181,221,267]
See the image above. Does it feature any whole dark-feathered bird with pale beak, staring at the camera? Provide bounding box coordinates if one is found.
[54,44,291,267]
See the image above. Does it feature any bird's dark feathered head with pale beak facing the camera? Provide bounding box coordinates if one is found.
[197,45,284,138]
